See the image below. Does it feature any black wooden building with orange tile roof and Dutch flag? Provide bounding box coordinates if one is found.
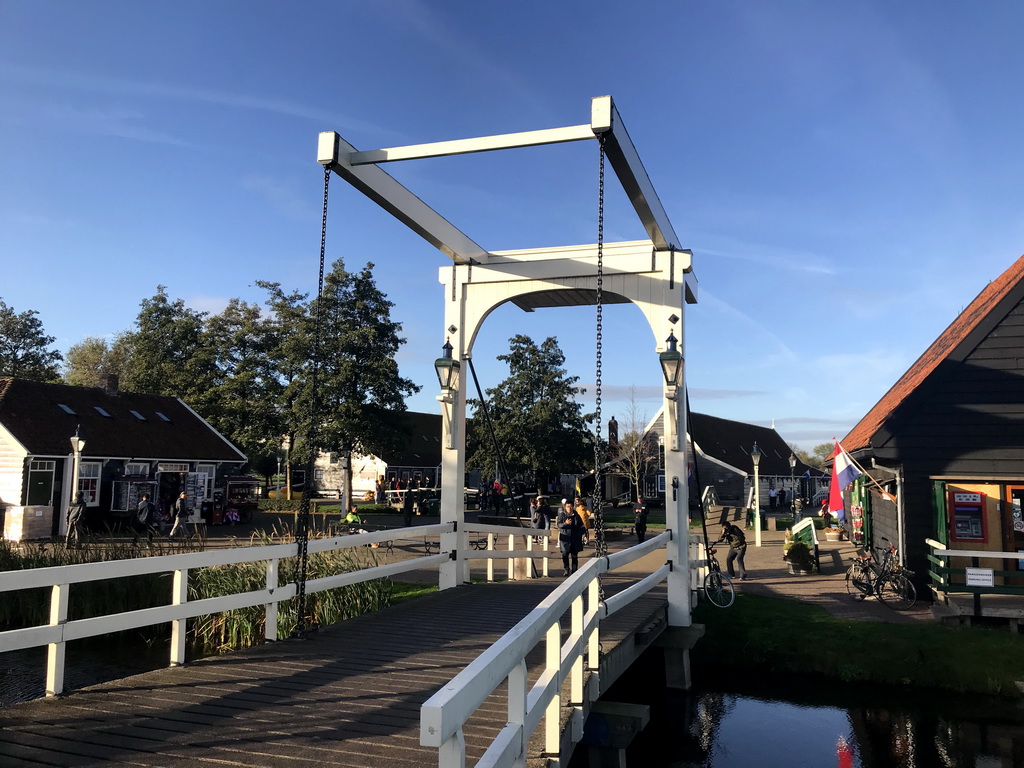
[843,256,1024,588]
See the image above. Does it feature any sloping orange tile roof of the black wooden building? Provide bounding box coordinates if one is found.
[843,256,1024,451]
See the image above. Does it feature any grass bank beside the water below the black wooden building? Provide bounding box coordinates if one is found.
[691,595,1024,696]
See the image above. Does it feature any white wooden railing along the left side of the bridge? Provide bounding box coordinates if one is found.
[0,523,561,696]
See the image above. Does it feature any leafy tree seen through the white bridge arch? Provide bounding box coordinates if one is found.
[468,335,594,483]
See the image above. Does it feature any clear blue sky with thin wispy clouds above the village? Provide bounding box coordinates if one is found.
[0,0,1024,449]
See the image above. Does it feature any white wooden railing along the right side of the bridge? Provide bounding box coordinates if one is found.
[420,530,672,768]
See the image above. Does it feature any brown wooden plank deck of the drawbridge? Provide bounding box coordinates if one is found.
[0,579,665,768]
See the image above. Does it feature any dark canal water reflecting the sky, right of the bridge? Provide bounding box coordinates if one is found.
[585,665,1024,768]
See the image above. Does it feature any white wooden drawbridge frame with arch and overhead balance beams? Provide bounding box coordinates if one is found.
[317,96,696,626]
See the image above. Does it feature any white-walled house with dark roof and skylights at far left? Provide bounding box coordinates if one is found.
[0,376,247,534]
